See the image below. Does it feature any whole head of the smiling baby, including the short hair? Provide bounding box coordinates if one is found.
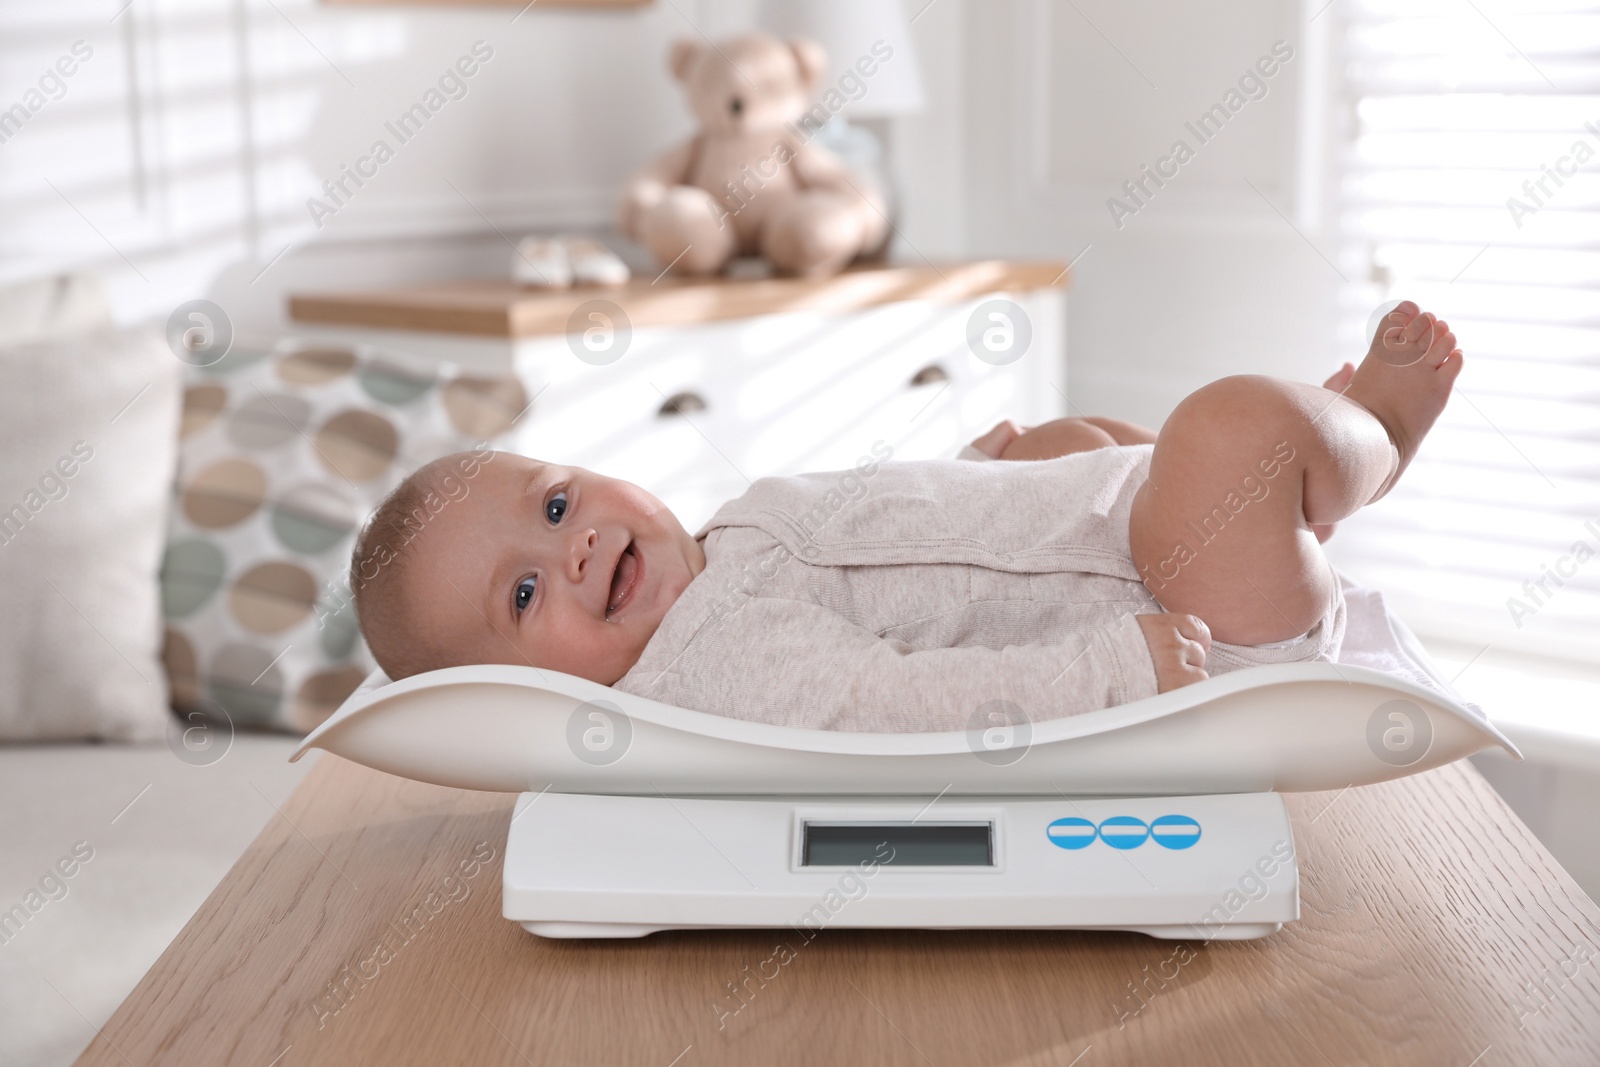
[350,451,706,685]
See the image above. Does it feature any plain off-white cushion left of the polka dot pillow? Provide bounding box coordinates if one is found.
[0,326,182,741]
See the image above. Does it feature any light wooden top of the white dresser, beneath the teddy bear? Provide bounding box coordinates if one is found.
[290,259,1067,338]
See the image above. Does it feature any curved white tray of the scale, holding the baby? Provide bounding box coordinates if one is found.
[290,662,1522,797]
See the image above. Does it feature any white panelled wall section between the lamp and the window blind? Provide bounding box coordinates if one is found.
[906,0,1357,426]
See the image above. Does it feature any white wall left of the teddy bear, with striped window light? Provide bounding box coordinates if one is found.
[0,0,749,337]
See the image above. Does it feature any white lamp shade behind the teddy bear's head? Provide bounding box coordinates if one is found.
[762,0,923,118]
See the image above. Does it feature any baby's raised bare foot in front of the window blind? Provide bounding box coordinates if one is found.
[1342,301,1462,504]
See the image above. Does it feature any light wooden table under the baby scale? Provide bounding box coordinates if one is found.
[78,755,1600,1067]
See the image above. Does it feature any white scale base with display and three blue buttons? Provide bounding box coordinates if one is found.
[502,792,1299,941]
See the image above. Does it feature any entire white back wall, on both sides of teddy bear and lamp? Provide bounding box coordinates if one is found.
[0,0,1339,424]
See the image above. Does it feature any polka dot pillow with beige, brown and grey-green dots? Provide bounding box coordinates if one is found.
[162,347,528,733]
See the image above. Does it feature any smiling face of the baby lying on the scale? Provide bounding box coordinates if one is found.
[406,453,706,685]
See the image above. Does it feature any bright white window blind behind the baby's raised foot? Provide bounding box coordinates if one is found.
[1322,0,1600,664]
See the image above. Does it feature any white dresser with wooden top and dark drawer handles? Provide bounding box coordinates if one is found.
[291,261,1067,531]
